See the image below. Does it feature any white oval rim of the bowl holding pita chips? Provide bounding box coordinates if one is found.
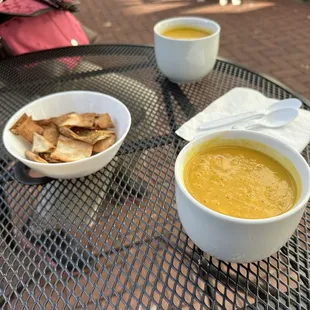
[2,90,131,169]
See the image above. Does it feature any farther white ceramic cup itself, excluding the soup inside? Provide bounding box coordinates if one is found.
[154,17,221,83]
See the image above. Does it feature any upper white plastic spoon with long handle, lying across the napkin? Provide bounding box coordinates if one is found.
[199,98,302,130]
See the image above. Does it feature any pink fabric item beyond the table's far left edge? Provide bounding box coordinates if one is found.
[0,0,89,55]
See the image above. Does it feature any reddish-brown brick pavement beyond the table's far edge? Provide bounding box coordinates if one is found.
[77,0,310,99]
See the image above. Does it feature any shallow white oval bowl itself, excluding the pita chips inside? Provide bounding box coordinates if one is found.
[3,91,131,179]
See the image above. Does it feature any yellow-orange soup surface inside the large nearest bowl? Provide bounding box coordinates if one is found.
[184,146,297,219]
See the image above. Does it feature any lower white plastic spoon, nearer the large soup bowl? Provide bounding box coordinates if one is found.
[232,108,298,129]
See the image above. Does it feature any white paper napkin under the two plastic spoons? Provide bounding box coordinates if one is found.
[176,88,310,153]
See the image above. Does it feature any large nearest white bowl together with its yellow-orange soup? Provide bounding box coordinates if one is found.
[175,130,310,263]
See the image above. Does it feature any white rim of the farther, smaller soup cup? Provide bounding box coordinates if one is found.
[153,16,221,42]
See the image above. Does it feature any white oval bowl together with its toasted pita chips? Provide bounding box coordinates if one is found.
[3,91,131,179]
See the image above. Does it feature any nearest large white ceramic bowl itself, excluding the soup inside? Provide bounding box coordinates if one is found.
[175,130,310,263]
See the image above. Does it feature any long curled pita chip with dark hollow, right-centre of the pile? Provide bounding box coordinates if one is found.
[59,127,114,144]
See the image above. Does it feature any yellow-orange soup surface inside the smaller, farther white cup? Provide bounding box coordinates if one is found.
[162,26,212,39]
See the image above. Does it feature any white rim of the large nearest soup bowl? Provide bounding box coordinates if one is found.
[174,129,310,224]
